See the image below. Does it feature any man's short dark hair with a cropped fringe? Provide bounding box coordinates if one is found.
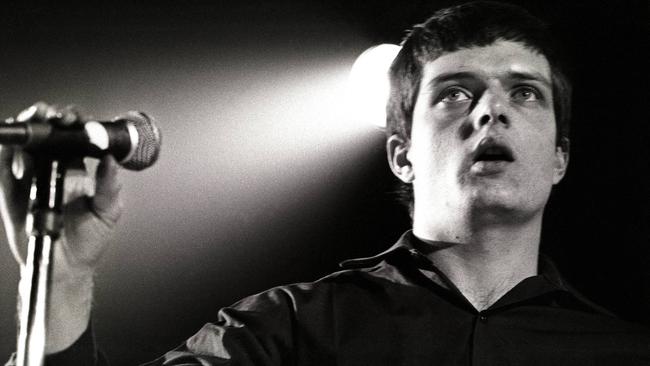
[386,1,571,215]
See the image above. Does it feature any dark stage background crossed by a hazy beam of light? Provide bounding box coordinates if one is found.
[0,0,650,365]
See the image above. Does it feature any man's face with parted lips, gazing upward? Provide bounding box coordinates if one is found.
[392,41,567,221]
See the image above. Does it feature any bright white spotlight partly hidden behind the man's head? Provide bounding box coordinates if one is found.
[348,44,401,127]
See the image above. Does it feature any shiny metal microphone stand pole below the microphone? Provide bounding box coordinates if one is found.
[16,155,67,366]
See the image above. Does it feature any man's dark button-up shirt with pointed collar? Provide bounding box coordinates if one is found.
[27,232,650,366]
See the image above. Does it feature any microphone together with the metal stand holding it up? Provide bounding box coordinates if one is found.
[5,111,161,366]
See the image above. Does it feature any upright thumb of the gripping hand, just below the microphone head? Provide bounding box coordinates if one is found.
[91,155,122,225]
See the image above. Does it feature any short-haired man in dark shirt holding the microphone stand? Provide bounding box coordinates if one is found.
[3,3,650,365]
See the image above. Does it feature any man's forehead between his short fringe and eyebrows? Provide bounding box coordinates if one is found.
[422,41,551,83]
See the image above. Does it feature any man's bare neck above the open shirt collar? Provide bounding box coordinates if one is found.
[413,210,541,311]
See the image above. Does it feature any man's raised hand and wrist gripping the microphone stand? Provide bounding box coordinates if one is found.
[0,103,122,353]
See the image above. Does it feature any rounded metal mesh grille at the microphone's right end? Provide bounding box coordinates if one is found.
[120,111,162,170]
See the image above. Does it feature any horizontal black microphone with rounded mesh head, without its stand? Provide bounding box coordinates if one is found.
[0,111,162,170]
